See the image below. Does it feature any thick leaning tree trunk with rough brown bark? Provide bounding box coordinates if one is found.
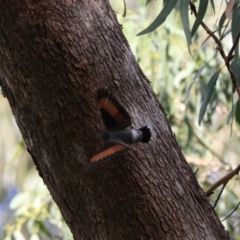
[0,0,229,240]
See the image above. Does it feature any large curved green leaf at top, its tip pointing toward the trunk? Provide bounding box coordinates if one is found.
[137,0,178,36]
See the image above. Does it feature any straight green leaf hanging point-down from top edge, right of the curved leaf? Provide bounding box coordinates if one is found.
[179,0,192,52]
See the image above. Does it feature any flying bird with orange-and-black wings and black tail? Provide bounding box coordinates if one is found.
[90,88,151,163]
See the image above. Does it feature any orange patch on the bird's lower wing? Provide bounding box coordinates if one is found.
[91,143,129,162]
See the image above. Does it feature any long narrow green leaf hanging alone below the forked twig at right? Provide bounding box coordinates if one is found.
[198,70,220,126]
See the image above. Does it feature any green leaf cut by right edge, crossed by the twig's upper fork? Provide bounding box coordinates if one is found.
[231,6,240,62]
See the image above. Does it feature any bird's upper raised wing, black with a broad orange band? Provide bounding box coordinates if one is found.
[97,88,132,131]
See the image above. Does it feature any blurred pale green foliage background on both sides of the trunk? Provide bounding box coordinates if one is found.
[0,0,240,240]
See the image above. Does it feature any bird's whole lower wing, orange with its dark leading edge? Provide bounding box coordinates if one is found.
[91,141,130,162]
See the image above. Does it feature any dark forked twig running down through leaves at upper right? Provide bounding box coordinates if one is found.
[189,2,240,99]
